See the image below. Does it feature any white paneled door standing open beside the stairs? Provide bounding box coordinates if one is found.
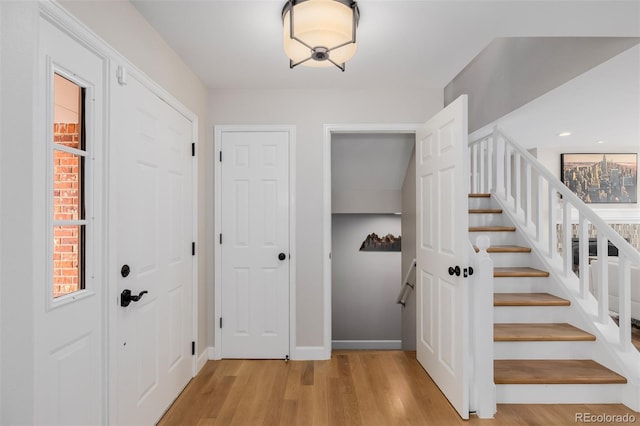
[416,95,469,419]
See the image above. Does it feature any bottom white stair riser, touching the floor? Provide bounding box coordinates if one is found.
[496,384,624,404]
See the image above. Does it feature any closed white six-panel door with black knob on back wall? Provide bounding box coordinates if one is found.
[218,131,290,358]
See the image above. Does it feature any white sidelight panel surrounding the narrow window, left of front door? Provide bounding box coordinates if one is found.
[35,18,106,425]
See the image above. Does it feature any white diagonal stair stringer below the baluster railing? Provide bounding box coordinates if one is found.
[490,193,640,411]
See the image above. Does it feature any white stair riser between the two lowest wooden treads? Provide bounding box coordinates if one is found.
[493,341,595,359]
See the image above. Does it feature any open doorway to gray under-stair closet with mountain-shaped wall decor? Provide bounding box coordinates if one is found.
[325,125,415,349]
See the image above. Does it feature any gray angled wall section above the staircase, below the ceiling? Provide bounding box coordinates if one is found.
[444,37,640,133]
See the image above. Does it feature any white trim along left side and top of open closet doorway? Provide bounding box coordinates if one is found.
[322,123,420,359]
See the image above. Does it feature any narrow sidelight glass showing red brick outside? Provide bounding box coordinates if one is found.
[51,74,86,298]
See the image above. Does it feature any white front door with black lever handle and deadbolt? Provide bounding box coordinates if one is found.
[111,70,194,425]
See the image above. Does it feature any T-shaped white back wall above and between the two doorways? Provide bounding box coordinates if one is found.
[206,87,443,347]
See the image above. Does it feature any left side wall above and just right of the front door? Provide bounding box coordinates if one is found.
[59,0,213,353]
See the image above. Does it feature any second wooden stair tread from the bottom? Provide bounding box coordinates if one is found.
[493,323,596,342]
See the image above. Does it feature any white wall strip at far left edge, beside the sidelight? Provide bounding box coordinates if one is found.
[0,2,38,425]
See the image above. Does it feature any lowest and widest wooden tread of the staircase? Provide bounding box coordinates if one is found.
[493,359,627,384]
